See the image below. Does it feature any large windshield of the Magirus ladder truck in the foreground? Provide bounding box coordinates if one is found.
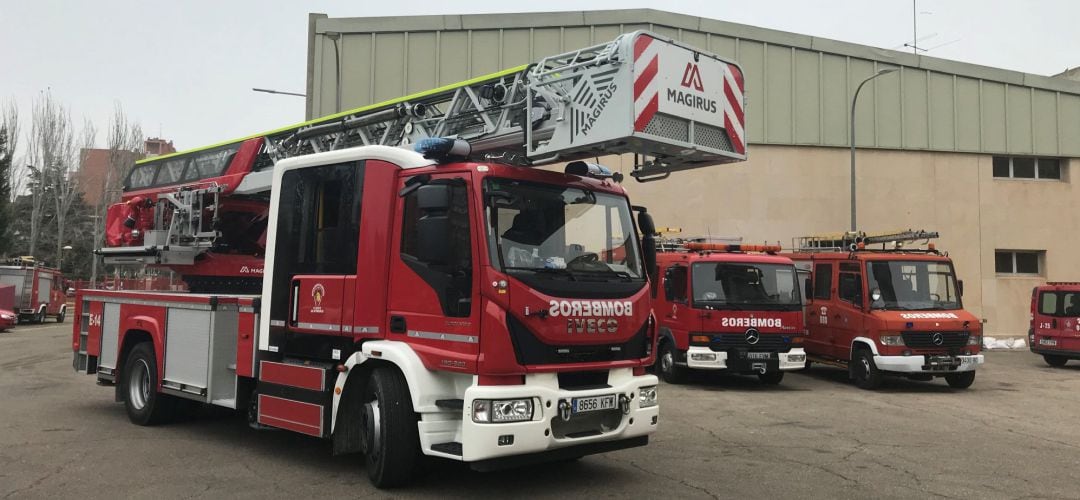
[485,178,644,281]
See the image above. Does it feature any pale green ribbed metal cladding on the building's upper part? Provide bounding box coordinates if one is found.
[308,10,1080,157]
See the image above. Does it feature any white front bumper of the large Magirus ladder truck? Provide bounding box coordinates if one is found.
[447,368,660,462]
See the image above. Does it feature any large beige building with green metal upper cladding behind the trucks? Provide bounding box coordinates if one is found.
[307,10,1080,337]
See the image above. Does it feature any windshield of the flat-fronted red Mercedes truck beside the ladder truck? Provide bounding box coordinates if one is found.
[692,262,802,310]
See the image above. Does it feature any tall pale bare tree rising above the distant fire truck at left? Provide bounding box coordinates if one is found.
[26,91,75,260]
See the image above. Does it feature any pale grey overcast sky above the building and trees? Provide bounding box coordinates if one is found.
[0,0,1080,149]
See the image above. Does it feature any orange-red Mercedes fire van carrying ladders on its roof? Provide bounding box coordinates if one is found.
[791,231,983,389]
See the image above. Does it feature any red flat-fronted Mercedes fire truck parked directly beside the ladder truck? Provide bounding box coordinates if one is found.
[654,240,806,384]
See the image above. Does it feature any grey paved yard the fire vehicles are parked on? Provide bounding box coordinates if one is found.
[0,325,1080,498]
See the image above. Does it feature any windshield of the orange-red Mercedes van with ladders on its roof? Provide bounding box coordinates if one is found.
[866,260,961,311]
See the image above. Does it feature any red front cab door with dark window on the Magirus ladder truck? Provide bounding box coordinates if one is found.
[388,174,483,370]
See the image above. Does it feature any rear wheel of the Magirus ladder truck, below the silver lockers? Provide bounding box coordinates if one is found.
[120,342,176,425]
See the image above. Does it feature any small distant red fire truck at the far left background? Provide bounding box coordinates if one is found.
[0,262,67,323]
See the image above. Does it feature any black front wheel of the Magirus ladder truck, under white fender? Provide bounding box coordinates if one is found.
[362,367,421,488]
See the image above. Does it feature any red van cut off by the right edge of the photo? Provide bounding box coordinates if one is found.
[1027,282,1080,366]
